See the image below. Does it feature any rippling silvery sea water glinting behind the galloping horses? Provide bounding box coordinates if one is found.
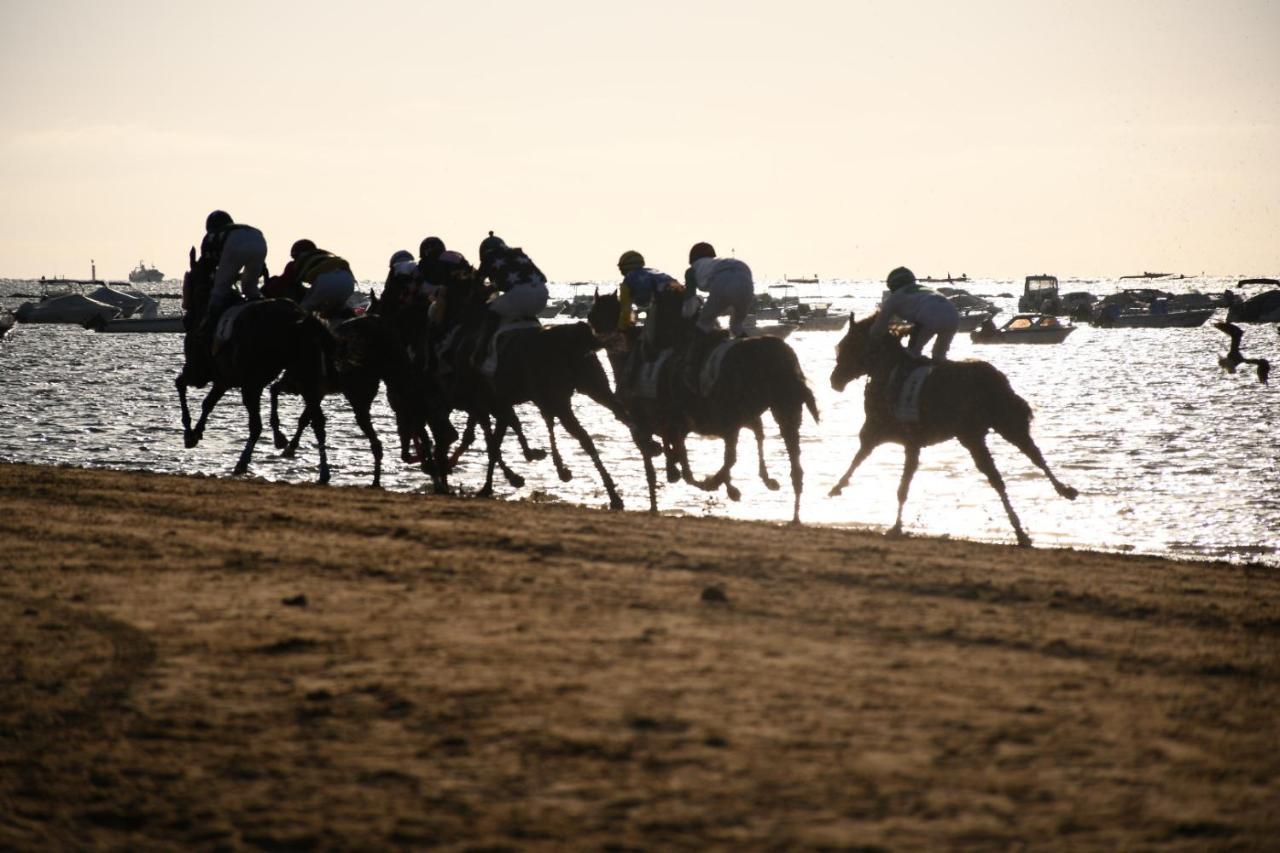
[0,279,1280,565]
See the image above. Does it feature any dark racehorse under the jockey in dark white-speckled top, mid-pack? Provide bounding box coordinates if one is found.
[440,274,627,510]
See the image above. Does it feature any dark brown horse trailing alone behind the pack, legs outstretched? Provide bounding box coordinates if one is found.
[831,314,1076,546]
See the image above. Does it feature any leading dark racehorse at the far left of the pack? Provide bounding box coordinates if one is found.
[174,248,333,483]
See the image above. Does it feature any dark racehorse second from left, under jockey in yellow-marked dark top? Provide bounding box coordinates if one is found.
[270,314,456,493]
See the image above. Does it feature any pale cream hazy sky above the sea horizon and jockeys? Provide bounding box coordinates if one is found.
[0,0,1280,282]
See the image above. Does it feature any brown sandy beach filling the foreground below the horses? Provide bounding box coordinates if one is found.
[0,465,1280,850]
